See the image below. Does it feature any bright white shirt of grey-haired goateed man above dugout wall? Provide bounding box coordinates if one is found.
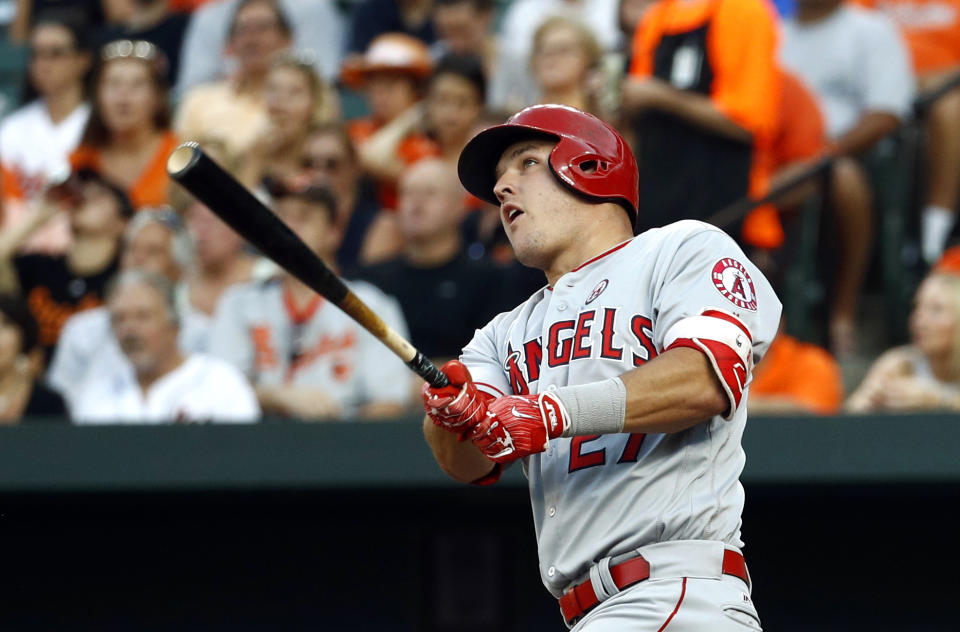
[73,353,260,424]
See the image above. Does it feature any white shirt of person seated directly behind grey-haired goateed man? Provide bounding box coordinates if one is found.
[47,285,212,410]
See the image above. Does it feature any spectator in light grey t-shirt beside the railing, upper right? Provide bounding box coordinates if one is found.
[780,0,914,354]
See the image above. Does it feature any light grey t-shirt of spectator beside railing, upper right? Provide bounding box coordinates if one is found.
[780,5,915,138]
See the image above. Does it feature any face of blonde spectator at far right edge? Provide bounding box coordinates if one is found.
[910,276,958,358]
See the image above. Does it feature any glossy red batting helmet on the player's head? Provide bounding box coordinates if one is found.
[457,105,640,227]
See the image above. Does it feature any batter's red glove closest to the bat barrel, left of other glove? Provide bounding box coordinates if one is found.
[421,360,494,441]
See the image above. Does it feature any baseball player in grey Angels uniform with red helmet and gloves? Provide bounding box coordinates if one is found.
[423,105,780,632]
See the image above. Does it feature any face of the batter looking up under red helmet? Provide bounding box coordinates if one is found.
[493,140,589,271]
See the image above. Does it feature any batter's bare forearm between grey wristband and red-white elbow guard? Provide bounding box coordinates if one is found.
[620,348,729,433]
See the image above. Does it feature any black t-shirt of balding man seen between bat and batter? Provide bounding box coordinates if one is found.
[357,254,515,358]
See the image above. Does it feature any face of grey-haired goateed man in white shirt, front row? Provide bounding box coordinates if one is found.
[109,284,177,374]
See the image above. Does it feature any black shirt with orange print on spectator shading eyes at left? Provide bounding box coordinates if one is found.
[13,254,118,361]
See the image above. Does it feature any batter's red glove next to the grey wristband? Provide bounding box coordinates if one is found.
[469,393,570,463]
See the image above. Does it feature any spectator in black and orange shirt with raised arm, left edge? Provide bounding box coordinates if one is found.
[0,170,133,358]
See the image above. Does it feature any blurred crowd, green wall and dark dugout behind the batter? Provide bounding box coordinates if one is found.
[0,0,960,631]
